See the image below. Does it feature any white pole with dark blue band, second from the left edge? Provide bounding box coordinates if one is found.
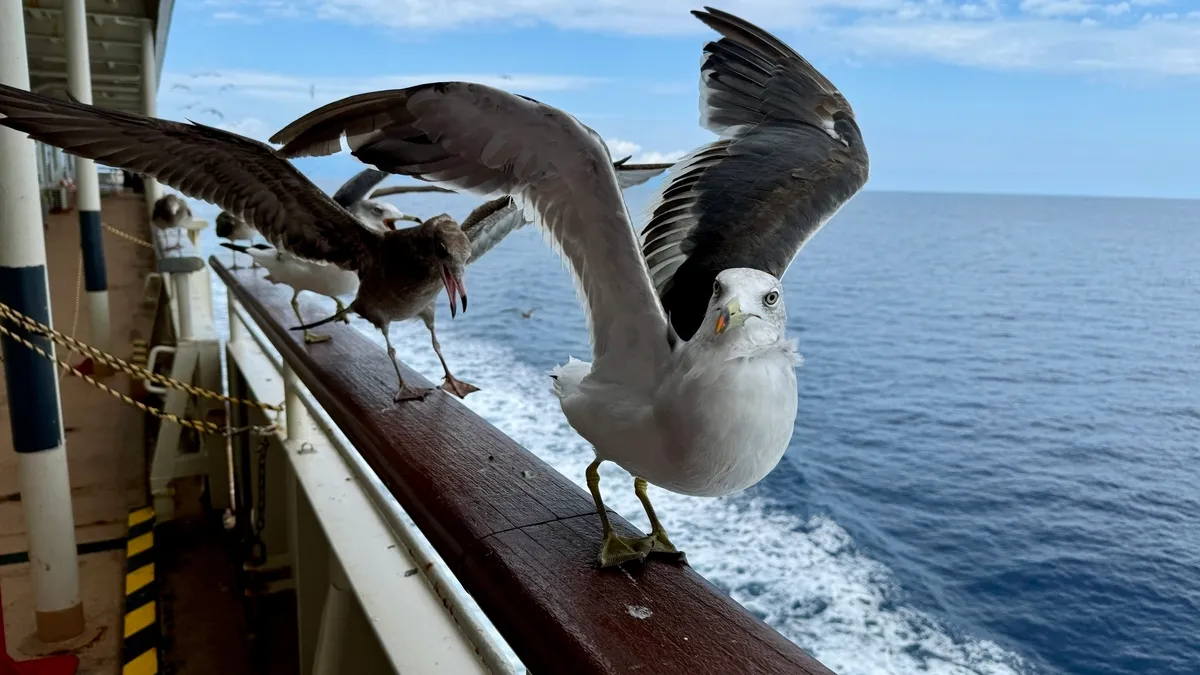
[62,0,113,376]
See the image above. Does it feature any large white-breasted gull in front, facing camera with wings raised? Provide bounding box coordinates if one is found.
[271,8,869,567]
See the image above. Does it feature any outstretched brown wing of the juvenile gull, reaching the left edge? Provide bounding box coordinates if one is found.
[0,84,380,269]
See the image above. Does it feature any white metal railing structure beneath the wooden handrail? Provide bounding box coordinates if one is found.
[150,222,524,675]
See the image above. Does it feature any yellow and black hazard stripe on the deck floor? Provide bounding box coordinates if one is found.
[121,507,161,675]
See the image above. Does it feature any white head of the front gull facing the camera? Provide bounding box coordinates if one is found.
[696,268,787,347]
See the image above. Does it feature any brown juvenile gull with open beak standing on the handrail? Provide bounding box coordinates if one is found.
[0,84,470,401]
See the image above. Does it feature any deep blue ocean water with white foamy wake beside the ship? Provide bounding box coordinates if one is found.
[202,189,1200,675]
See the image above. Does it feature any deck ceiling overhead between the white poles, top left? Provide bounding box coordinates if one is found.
[24,0,174,113]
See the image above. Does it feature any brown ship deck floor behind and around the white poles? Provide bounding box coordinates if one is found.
[0,195,154,674]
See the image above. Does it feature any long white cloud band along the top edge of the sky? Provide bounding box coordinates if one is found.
[201,0,1200,77]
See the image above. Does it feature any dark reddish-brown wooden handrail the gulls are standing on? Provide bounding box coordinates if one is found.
[209,256,832,675]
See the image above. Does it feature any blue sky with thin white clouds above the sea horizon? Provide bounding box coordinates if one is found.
[158,0,1200,198]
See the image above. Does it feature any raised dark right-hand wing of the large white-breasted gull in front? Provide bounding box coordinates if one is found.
[641,7,869,340]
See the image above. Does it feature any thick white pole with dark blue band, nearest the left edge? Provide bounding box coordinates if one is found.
[0,0,84,643]
